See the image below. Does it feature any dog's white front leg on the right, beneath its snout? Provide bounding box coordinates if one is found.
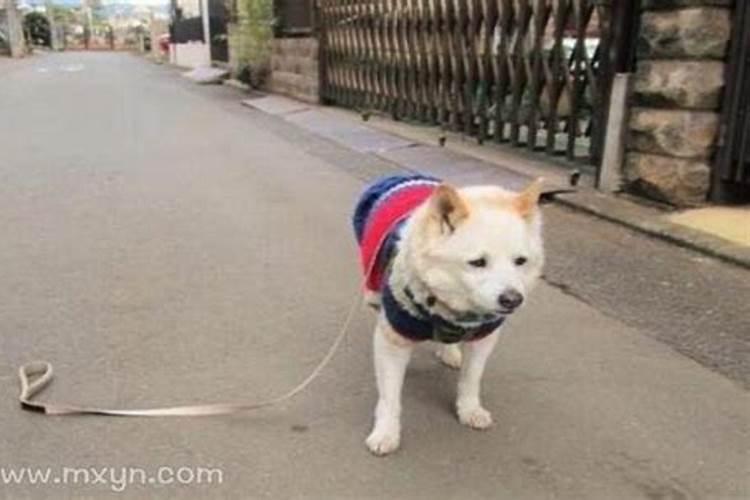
[456,331,499,429]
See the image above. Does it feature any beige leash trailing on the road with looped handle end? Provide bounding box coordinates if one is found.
[18,292,369,417]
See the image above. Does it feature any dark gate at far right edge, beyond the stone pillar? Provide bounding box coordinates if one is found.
[711,1,750,201]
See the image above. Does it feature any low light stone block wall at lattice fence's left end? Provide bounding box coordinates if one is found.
[268,37,320,103]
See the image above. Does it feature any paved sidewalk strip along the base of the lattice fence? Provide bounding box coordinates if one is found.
[243,95,750,268]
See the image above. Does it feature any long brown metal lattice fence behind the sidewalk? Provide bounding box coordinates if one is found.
[318,0,617,163]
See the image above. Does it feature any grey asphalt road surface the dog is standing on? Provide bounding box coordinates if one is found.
[0,53,750,500]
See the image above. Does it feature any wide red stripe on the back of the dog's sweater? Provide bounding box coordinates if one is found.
[360,185,437,292]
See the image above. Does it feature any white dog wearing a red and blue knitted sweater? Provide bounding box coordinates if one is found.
[354,175,544,455]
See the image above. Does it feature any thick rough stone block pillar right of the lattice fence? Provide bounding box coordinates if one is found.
[624,0,744,206]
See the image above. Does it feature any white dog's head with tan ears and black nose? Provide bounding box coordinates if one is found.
[404,179,544,314]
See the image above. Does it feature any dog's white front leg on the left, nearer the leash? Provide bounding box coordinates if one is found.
[366,315,413,455]
